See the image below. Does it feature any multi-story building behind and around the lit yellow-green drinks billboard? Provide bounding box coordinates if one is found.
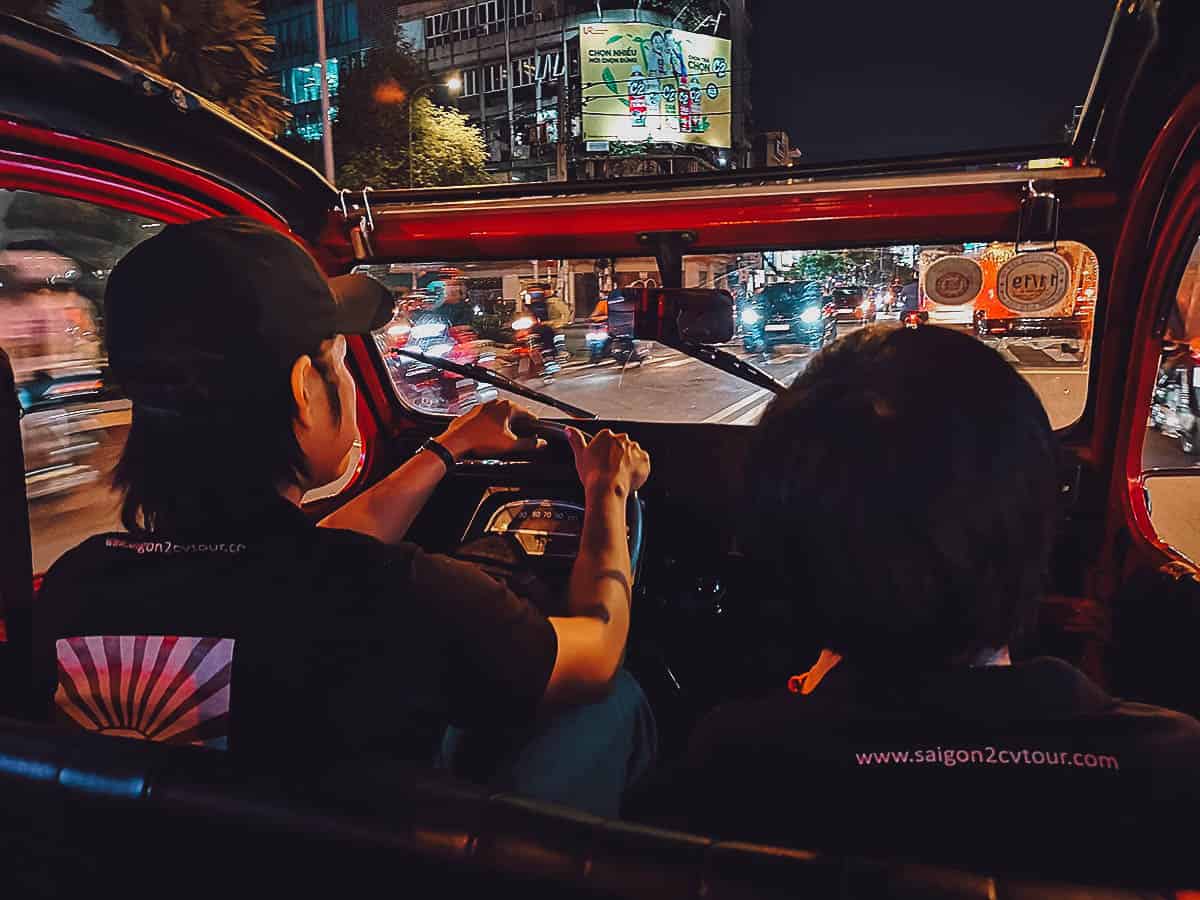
[397,0,751,181]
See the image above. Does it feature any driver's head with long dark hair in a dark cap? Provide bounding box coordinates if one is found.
[104,218,392,530]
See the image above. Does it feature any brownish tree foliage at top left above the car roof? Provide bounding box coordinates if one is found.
[88,0,289,137]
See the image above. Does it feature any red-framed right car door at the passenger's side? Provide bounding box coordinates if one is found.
[1097,130,1200,715]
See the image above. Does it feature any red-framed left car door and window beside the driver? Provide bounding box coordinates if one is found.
[0,17,350,709]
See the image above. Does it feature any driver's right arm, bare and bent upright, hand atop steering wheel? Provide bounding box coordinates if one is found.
[542,428,650,706]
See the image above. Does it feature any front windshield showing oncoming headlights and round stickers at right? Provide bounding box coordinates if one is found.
[358,241,1099,428]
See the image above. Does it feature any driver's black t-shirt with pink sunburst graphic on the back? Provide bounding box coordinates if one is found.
[35,499,557,762]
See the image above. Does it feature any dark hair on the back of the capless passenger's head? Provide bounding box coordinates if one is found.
[746,326,1057,667]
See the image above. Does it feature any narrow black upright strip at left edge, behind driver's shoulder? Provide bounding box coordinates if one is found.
[0,348,34,715]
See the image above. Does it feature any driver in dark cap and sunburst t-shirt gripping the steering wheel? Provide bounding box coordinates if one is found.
[35,218,653,812]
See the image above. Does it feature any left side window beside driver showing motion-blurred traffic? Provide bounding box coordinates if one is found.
[0,190,356,572]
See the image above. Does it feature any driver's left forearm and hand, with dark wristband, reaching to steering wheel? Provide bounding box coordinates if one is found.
[319,400,538,544]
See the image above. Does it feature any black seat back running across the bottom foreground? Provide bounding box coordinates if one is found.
[0,720,1170,900]
